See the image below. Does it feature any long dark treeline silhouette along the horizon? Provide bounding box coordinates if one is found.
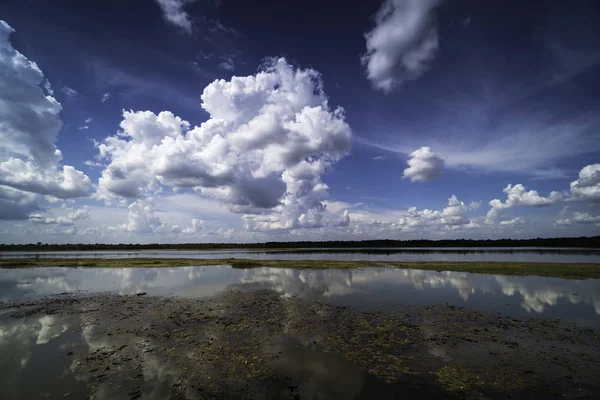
[0,236,600,251]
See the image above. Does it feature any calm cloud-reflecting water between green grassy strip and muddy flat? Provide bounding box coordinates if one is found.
[0,266,600,327]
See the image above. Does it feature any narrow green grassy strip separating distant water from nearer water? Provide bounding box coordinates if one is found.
[0,258,600,279]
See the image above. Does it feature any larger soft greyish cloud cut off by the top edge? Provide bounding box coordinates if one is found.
[362,0,442,92]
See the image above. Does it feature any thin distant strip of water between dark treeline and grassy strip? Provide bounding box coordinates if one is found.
[0,247,600,263]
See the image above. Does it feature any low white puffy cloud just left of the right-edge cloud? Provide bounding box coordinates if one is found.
[487,184,567,223]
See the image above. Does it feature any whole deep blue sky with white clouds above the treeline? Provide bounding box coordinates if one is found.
[0,0,600,243]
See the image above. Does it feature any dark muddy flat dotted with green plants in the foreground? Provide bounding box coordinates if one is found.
[0,290,600,399]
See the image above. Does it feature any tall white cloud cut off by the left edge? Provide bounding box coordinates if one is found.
[0,21,91,217]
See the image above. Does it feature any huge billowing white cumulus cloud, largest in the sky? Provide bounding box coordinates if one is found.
[96,58,351,230]
